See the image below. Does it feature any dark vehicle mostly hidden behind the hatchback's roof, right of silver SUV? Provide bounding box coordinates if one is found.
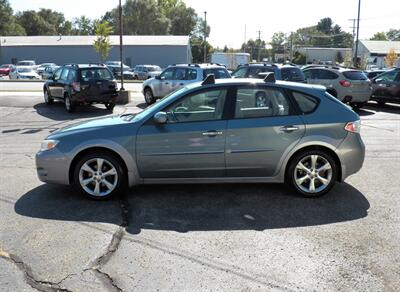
[232,63,305,83]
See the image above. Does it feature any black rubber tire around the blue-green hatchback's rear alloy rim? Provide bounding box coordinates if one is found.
[286,150,338,198]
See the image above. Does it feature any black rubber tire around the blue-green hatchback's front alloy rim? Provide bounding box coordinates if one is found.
[72,151,126,200]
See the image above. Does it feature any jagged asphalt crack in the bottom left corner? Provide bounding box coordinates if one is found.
[0,250,71,292]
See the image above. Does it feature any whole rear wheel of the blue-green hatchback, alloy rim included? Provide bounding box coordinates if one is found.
[287,150,337,197]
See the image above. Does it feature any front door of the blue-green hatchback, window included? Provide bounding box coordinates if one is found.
[136,87,228,179]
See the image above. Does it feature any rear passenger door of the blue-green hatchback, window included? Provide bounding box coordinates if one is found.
[225,85,305,177]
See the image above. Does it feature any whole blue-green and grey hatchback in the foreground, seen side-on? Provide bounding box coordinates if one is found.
[36,74,365,199]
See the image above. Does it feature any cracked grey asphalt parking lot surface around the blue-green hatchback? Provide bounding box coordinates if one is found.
[0,93,400,291]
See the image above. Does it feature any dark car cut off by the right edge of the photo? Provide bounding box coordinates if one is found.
[371,68,400,105]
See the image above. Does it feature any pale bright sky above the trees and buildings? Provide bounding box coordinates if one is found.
[9,0,400,48]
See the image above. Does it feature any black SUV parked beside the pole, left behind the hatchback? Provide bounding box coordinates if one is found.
[43,64,118,112]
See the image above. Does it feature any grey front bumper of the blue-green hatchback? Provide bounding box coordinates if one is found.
[36,148,69,184]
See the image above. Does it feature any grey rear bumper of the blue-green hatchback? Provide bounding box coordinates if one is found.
[336,133,365,181]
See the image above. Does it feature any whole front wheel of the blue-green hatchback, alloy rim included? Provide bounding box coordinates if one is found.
[73,152,125,200]
